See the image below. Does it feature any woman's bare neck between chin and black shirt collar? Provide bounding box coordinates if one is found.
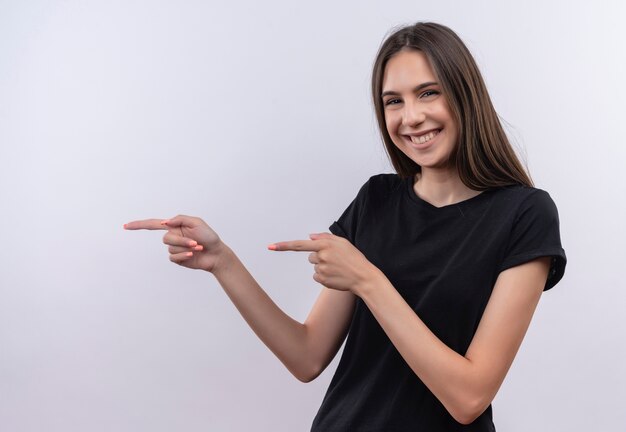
[413,168,480,207]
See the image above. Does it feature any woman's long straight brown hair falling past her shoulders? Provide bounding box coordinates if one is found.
[372,22,533,190]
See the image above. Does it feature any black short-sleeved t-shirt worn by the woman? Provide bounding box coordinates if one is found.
[311,174,566,432]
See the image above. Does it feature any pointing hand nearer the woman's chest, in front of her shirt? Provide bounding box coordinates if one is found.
[268,233,381,295]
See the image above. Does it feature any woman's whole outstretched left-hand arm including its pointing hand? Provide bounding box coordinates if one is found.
[124,215,356,382]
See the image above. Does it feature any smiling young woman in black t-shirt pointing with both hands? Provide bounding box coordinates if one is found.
[125,23,566,432]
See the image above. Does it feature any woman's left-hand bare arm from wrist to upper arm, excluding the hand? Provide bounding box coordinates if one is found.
[212,246,355,382]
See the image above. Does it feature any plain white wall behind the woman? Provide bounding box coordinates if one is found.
[0,0,626,432]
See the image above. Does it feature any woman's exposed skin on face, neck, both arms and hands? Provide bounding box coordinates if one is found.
[124,51,550,424]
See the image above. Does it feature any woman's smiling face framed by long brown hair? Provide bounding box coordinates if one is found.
[382,50,458,171]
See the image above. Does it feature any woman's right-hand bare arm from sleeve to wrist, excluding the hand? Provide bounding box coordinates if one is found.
[355,258,550,424]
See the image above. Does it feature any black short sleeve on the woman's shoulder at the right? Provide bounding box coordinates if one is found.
[500,189,567,291]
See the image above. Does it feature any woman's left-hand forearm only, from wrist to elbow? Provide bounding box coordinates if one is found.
[212,245,315,381]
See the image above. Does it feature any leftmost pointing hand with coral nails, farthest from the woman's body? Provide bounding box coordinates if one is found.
[124,215,225,272]
